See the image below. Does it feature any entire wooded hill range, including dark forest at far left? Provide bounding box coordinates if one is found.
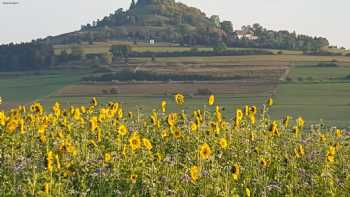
[0,0,340,71]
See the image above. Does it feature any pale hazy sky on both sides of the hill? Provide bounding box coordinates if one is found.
[0,0,350,48]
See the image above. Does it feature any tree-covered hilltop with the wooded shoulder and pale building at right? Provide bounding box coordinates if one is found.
[48,0,329,51]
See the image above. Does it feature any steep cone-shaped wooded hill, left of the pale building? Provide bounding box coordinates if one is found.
[48,0,228,45]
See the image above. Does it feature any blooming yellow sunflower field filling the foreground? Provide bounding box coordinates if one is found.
[0,94,350,197]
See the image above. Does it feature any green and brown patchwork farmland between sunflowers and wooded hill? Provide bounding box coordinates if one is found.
[0,55,350,128]
